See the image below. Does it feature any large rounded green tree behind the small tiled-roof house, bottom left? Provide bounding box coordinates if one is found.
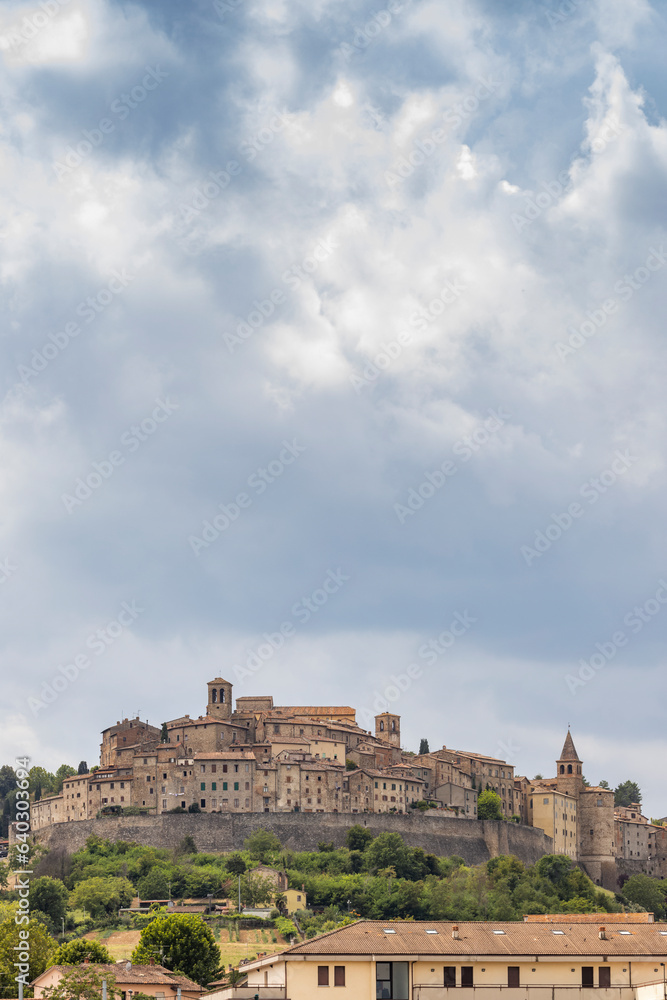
[132,913,220,986]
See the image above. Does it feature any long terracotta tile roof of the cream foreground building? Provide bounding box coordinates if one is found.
[247,913,667,959]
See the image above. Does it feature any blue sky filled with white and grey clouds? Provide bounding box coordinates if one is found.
[0,0,667,816]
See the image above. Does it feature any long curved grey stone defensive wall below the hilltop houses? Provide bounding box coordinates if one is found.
[28,812,553,865]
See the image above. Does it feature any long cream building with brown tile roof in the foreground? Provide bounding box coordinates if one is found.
[236,914,667,1000]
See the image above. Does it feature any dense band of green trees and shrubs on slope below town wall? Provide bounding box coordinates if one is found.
[37,826,636,920]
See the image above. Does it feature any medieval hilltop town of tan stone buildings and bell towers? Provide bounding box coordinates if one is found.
[32,677,667,883]
